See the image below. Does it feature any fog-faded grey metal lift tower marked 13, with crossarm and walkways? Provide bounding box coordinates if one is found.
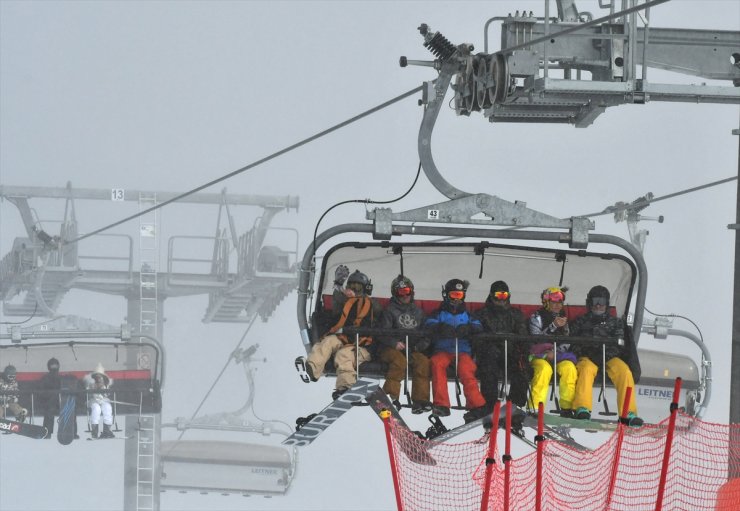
[0,183,298,511]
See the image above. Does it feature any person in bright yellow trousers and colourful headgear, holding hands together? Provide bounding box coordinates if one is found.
[529,287,578,417]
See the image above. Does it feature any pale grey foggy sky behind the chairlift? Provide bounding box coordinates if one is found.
[0,0,740,511]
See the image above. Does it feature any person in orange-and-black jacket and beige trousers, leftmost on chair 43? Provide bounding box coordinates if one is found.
[306,265,383,400]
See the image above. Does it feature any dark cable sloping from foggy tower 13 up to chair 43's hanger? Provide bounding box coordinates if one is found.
[62,85,424,245]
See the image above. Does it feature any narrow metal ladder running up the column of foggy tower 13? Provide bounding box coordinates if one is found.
[136,192,159,511]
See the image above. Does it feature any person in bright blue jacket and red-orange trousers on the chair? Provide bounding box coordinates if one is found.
[426,279,486,421]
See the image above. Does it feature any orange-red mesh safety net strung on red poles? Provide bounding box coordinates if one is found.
[391,413,740,511]
